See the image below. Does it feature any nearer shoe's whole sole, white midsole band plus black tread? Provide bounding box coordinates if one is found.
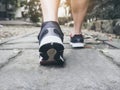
[39,36,64,65]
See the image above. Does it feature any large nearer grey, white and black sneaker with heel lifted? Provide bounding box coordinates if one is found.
[38,21,64,65]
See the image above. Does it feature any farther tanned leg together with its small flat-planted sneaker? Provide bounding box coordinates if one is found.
[70,0,89,47]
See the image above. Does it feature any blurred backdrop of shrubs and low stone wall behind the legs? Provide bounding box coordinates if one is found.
[0,0,120,39]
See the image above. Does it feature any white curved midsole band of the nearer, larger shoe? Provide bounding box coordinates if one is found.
[40,36,63,47]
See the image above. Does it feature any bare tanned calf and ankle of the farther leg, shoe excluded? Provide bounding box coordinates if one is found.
[71,0,89,35]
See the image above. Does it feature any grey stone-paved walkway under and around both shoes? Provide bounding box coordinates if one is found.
[0,27,120,90]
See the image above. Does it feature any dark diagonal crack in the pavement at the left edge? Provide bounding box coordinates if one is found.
[0,51,22,70]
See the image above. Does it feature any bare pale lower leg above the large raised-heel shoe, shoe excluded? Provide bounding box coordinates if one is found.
[40,0,60,22]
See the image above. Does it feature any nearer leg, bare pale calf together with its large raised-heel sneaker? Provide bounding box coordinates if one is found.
[38,0,64,65]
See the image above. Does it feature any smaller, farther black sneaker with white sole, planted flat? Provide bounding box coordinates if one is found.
[70,34,85,48]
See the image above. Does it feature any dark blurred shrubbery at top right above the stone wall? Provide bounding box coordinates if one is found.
[87,0,120,19]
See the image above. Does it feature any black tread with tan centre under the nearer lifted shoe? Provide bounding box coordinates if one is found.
[40,43,64,65]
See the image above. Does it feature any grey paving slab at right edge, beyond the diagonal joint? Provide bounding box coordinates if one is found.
[102,49,120,66]
